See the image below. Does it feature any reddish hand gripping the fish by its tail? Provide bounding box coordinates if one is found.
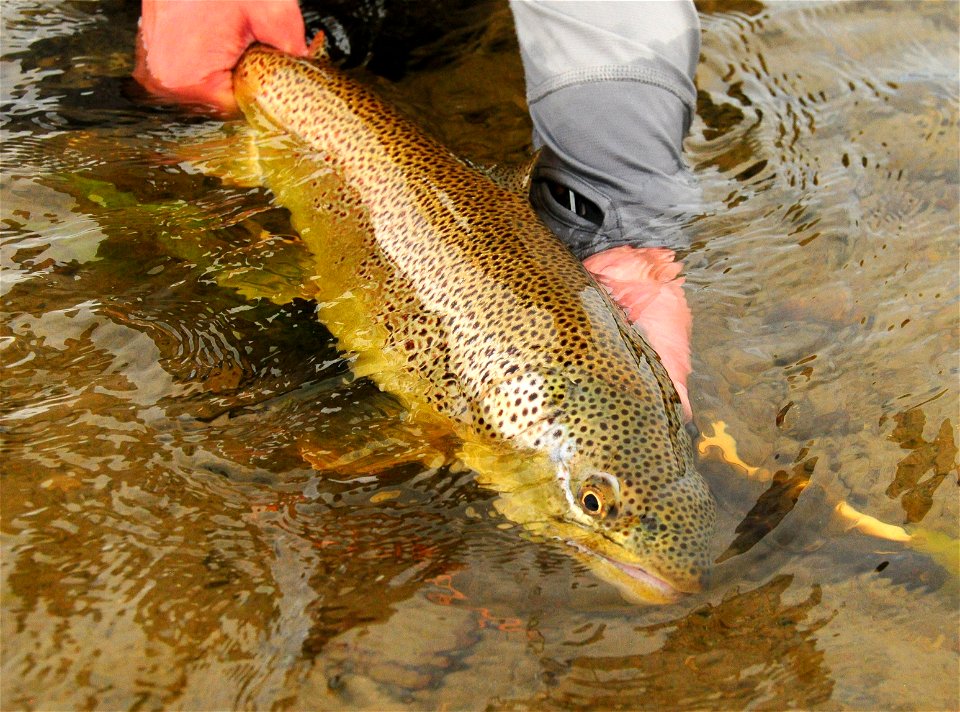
[133,0,307,113]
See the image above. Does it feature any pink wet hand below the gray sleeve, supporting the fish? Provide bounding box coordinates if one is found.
[583,247,693,420]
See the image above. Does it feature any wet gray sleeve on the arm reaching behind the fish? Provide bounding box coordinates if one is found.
[510,0,700,259]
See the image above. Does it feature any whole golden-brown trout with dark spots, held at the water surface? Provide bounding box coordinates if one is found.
[234,47,715,600]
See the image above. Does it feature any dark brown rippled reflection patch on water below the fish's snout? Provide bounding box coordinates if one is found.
[503,576,833,709]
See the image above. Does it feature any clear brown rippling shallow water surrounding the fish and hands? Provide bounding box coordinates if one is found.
[0,2,960,709]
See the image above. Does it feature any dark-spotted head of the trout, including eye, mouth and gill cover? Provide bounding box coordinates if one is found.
[478,362,716,603]
